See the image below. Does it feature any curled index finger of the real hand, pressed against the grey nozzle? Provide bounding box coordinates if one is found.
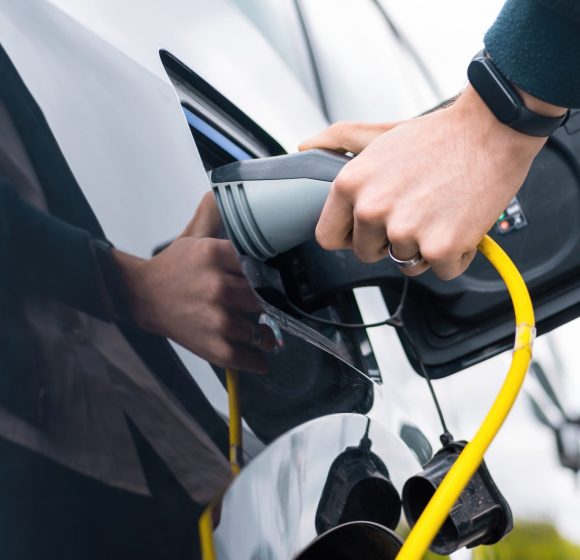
[316,182,354,251]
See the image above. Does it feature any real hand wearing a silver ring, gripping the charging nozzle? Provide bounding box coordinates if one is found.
[300,86,561,280]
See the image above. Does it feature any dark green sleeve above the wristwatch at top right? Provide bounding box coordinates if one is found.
[484,0,580,108]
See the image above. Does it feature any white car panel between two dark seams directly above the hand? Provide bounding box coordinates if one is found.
[300,0,437,121]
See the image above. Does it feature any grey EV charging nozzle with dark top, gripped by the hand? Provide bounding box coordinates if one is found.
[210,150,350,261]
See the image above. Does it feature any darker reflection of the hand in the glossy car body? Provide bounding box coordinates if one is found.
[114,193,275,373]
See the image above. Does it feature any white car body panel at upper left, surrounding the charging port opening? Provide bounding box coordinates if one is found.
[0,0,324,256]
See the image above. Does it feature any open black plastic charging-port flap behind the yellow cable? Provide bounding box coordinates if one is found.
[392,119,580,377]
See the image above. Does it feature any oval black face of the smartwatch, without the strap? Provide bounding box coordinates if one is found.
[467,58,521,124]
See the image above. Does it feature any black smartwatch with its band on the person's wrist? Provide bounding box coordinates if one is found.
[467,50,570,136]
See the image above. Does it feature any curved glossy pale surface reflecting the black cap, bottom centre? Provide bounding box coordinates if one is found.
[214,414,419,560]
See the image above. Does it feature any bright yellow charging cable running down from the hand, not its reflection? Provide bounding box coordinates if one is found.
[397,235,536,560]
